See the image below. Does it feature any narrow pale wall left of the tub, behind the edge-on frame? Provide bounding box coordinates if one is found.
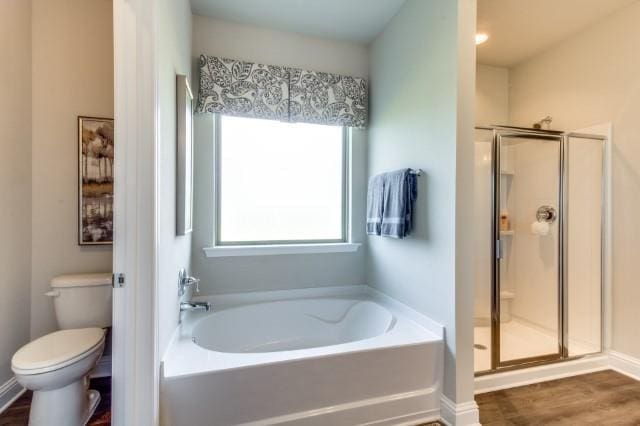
[156,0,192,356]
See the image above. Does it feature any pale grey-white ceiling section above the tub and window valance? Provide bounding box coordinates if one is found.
[191,0,405,43]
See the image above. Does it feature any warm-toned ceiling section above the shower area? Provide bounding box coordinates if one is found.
[477,0,639,67]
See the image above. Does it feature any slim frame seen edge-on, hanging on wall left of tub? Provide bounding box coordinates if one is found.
[176,75,193,235]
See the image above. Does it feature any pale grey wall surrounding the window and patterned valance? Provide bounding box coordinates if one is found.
[192,16,368,294]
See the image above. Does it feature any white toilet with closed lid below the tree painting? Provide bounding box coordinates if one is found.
[11,273,112,426]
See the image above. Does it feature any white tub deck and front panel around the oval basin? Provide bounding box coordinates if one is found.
[161,287,443,426]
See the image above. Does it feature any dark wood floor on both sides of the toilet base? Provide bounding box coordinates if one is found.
[0,377,111,426]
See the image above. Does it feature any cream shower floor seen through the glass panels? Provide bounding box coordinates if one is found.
[473,318,599,371]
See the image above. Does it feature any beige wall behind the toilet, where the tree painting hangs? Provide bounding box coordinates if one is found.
[30,0,117,338]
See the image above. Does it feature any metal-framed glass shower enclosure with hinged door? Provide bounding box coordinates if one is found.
[474,126,605,374]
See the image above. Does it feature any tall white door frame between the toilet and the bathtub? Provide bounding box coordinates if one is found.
[111,0,159,426]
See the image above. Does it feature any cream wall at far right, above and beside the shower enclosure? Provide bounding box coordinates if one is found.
[509,2,640,358]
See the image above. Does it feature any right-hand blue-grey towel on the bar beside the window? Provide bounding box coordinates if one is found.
[379,169,418,238]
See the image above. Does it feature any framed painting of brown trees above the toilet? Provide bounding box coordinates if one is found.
[78,117,114,245]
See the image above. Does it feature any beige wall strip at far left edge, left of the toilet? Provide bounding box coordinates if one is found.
[0,0,31,386]
